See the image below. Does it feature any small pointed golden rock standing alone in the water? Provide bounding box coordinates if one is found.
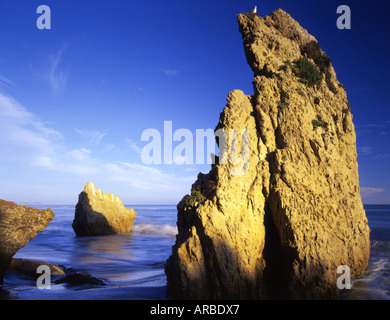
[72,182,137,236]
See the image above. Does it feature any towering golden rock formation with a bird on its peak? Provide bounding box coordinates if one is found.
[166,9,370,299]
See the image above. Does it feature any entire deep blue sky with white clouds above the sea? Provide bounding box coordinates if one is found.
[0,0,390,204]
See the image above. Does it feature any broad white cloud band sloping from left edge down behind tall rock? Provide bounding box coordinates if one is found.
[0,93,197,203]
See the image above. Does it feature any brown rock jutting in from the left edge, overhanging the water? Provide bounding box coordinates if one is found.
[0,200,54,283]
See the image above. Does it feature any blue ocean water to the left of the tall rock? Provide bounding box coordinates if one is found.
[0,206,177,300]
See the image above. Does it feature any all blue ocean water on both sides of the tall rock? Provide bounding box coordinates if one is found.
[0,205,390,300]
